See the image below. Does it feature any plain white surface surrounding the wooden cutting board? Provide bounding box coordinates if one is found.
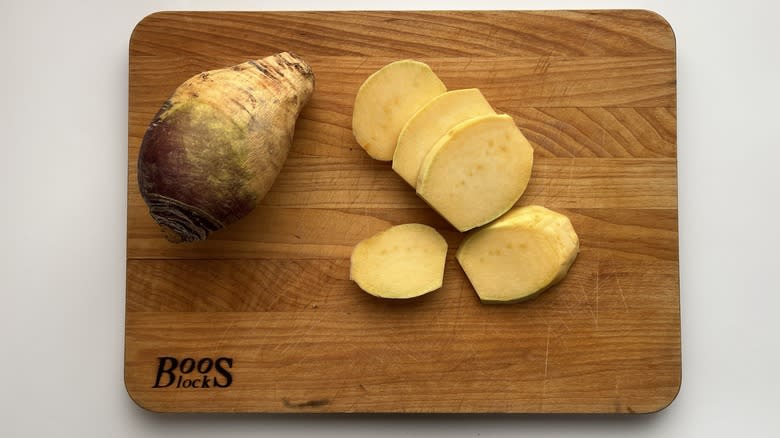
[0,0,780,438]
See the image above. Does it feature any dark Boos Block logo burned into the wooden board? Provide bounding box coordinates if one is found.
[152,356,233,389]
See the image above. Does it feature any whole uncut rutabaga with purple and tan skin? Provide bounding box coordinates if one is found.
[138,52,314,242]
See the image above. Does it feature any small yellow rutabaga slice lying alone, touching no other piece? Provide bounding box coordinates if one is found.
[349,224,447,298]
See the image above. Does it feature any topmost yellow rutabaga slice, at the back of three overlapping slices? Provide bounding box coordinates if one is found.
[352,59,447,161]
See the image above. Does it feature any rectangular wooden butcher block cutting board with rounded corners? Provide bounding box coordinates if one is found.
[125,11,680,413]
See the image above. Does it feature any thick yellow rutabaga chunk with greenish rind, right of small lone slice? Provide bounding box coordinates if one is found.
[456,206,579,303]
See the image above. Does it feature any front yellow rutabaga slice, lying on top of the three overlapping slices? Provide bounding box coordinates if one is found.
[417,114,533,231]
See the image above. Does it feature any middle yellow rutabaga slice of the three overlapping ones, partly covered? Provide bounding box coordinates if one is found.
[393,88,495,187]
